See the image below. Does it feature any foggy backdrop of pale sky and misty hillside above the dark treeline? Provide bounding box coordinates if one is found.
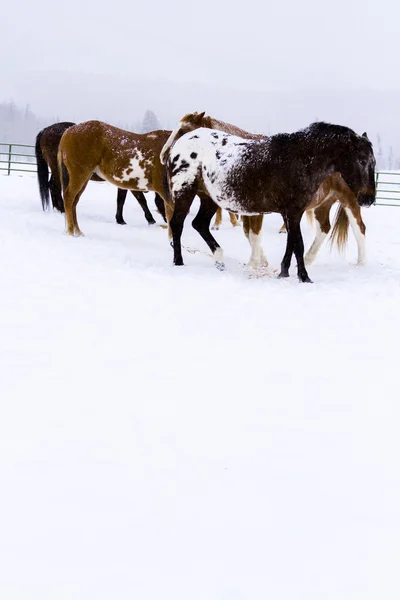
[0,0,400,151]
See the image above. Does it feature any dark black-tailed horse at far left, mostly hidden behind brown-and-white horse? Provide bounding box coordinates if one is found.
[35,121,165,225]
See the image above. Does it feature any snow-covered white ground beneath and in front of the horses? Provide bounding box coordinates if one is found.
[0,176,400,600]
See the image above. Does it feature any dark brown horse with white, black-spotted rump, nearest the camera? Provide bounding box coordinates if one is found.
[162,122,376,282]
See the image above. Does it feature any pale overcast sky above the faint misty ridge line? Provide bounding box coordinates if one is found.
[0,0,400,91]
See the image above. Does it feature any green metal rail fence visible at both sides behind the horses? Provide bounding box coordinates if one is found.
[0,143,400,207]
